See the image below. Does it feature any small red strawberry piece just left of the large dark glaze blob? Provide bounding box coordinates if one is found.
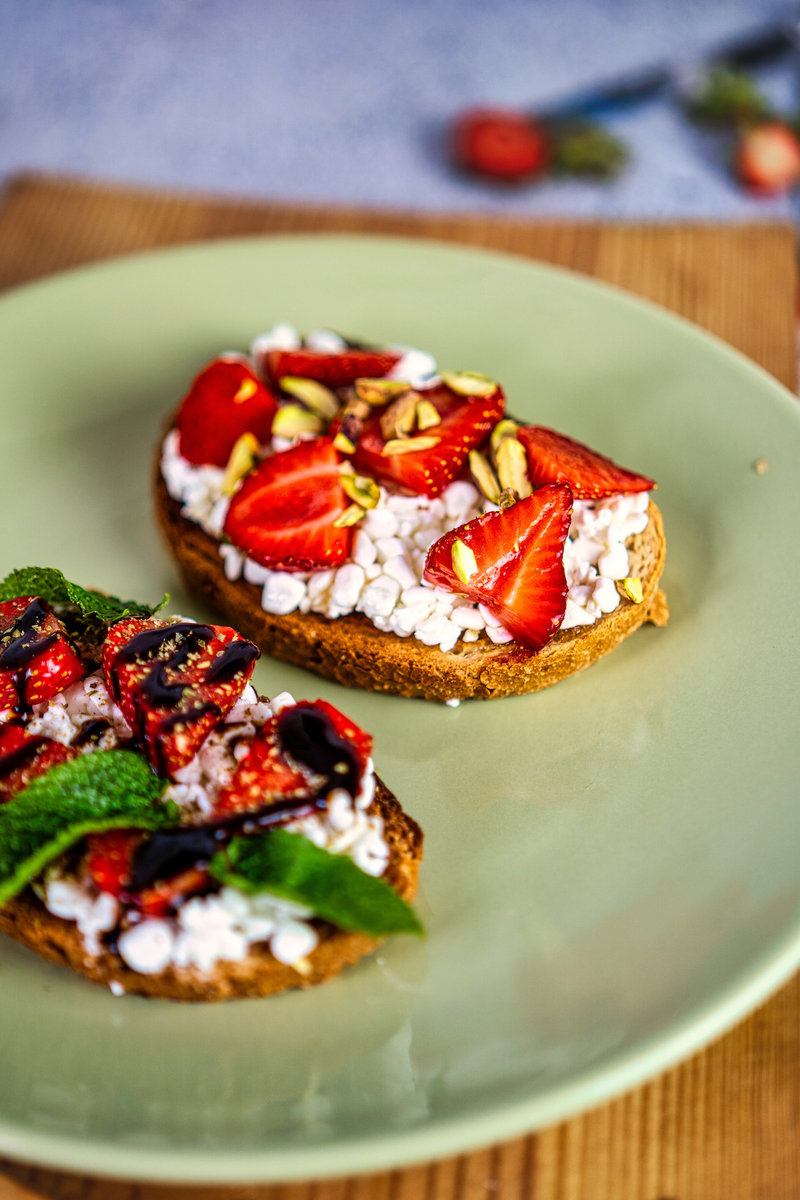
[215,716,313,816]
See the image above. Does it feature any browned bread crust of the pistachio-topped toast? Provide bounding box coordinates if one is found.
[155,451,669,701]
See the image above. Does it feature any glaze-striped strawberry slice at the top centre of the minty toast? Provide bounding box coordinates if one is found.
[103,617,259,776]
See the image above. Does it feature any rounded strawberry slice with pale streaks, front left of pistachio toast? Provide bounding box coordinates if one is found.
[223,438,353,571]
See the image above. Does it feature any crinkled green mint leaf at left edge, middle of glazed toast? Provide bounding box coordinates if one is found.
[0,750,180,906]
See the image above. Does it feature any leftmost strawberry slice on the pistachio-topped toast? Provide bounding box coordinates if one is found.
[176,358,277,467]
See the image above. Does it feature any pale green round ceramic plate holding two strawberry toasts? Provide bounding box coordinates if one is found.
[0,236,800,1182]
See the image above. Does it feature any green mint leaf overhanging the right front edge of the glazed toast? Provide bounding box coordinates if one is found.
[210,829,422,937]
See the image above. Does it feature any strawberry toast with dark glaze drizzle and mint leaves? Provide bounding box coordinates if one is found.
[0,569,422,1001]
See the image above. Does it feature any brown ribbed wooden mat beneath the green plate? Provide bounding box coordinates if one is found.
[0,175,800,1200]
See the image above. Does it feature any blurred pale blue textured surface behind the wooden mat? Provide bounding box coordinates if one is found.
[0,0,798,218]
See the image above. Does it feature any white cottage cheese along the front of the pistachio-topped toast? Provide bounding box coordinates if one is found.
[161,430,650,650]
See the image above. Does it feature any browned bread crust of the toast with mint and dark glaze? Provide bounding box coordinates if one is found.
[0,780,422,1001]
